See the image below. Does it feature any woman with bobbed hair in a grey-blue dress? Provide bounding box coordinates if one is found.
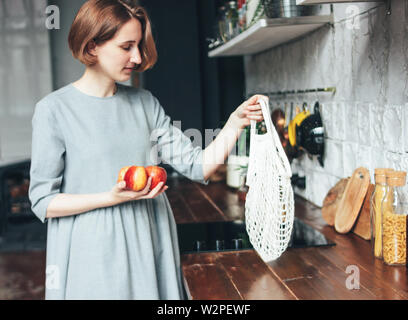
[29,0,263,299]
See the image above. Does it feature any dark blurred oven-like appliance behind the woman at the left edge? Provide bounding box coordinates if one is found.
[0,161,47,252]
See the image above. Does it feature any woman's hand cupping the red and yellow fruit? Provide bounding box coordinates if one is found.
[110,177,169,203]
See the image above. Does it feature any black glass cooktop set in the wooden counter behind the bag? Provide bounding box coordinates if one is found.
[177,218,335,254]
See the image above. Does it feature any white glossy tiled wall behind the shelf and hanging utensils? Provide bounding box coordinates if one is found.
[245,0,408,206]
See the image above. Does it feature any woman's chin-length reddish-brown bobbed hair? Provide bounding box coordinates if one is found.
[68,0,157,72]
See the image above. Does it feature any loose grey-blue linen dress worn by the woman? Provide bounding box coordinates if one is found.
[29,84,208,300]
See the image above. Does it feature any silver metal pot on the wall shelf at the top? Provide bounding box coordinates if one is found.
[262,0,313,19]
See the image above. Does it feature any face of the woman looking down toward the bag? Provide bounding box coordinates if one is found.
[94,18,143,82]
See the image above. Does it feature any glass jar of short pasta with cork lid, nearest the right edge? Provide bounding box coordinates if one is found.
[381,171,408,265]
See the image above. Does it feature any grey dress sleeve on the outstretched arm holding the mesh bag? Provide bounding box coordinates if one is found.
[151,92,209,185]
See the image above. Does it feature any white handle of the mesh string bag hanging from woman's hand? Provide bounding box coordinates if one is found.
[250,98,292,176]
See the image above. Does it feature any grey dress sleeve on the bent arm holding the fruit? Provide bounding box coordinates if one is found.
[29,102,65,223]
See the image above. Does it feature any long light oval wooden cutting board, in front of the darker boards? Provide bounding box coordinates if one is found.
[334,167,370,233]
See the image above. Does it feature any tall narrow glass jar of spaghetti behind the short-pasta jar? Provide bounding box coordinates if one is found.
[370,168,393,259]
